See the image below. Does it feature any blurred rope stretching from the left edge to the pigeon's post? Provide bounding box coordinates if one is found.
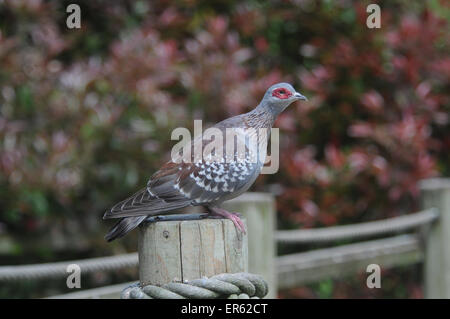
[0,253,138,281]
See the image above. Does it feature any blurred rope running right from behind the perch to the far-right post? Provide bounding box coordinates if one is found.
[275,208,439,244]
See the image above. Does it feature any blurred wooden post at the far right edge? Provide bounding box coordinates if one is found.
[420,178,450,298]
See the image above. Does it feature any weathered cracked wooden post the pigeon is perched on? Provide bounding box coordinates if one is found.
[138,219,248,285]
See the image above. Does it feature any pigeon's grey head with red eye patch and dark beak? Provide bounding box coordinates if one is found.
[262,83,308,114]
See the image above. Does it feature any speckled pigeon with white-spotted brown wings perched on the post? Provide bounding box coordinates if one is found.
[103,83,307,241]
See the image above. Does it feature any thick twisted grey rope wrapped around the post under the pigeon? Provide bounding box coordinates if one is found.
[121,272,269,299]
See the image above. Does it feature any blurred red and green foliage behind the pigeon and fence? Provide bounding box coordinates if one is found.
[0,0,450,298]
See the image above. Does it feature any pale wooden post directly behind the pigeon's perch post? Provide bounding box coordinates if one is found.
[223,193,277,298]
